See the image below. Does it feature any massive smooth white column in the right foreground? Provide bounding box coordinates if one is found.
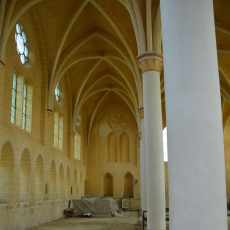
[161,0,227,230]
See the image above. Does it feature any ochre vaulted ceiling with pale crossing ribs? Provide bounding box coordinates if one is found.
[0,0,230,132]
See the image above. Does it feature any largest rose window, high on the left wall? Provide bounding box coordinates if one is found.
[15,23,29,65]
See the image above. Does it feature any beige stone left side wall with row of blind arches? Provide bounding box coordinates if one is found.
[0,11,86,229]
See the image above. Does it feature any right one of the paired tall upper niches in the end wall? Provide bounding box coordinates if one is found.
[119,133,129,162]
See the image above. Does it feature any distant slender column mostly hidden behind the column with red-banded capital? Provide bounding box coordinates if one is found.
[138,107,147,211]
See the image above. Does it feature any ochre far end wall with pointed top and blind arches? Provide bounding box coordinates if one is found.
[86,106,140,208]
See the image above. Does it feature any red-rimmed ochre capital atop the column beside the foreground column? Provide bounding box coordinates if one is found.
[137,53,163,73]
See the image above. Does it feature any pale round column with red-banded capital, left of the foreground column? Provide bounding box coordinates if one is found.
[138,53,165,230]
